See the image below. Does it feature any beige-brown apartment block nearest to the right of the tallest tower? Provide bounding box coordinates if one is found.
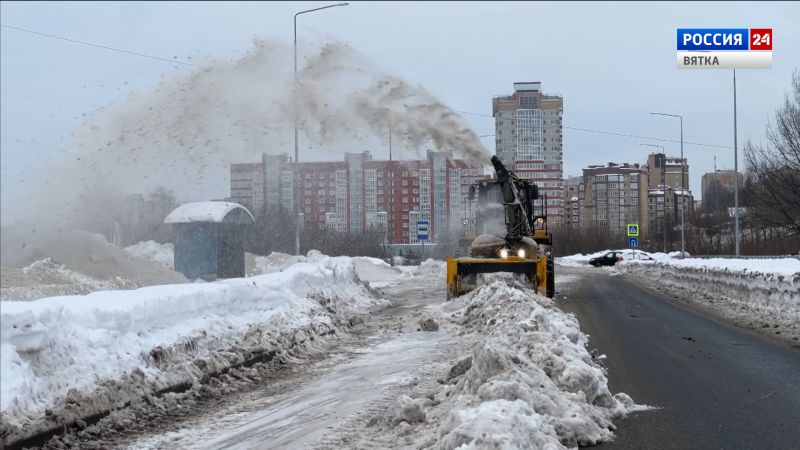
[570,163,648,234]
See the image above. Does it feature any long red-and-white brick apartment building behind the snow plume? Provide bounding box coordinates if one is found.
[230,151,484,244]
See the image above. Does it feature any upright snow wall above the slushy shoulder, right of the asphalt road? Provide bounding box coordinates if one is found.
[617,258,800,323]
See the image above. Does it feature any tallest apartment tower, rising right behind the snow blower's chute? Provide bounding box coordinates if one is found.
[492,81,564,223]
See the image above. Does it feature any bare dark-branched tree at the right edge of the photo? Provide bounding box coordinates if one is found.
[745,71,800,234]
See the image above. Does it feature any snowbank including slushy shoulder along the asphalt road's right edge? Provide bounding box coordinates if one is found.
[616,258,800,342]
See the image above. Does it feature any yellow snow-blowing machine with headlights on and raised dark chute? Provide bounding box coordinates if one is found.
[447,156,555,299]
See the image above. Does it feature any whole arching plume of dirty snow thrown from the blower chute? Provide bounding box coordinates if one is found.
[21,40,490,234]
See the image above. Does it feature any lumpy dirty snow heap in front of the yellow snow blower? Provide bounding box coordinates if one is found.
[379,275,646,449]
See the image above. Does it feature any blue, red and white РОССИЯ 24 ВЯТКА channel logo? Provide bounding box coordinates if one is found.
[676,28,772,69]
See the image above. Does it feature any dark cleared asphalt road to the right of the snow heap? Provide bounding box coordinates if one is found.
[556,267,800,449]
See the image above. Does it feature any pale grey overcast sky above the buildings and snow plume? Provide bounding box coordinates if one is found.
[0,2,800,220]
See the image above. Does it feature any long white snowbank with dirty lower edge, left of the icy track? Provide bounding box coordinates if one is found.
[0,254,386,441]
